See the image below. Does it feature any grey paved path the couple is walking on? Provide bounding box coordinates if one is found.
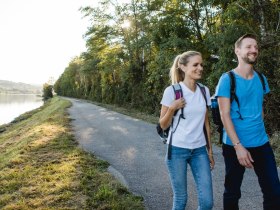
[66,98,278,210]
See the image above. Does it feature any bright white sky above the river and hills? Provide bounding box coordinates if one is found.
[0,0,98,84]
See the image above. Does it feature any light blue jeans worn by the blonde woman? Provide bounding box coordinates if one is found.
[166,146,213,210]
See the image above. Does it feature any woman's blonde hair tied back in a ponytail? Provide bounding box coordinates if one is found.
[169,51,201,84]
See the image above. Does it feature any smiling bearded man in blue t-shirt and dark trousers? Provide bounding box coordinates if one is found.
[216,34,280,210]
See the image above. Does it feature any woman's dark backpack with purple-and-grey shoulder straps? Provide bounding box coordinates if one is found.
[156,83,209,160]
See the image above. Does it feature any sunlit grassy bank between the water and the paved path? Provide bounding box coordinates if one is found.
[0,98,144,210]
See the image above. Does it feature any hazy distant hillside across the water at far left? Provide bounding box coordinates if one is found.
[0,80,43,95]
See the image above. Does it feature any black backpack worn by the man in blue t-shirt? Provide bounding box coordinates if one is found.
[211,70,266,144]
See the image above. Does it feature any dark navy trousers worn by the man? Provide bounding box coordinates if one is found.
[223,143,280,210]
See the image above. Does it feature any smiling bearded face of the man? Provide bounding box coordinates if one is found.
[235,38,259,64]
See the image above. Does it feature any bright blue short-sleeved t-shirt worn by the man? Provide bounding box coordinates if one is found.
[215,71,270,147]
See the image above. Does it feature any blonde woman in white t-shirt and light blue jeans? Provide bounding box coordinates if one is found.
[159,51,215,210]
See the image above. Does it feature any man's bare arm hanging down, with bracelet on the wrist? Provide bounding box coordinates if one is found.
[218,97,254,168]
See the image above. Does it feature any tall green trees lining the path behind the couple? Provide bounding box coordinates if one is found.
[54,0,280,133]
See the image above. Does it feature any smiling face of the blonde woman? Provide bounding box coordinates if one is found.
[180,55,203,80]
